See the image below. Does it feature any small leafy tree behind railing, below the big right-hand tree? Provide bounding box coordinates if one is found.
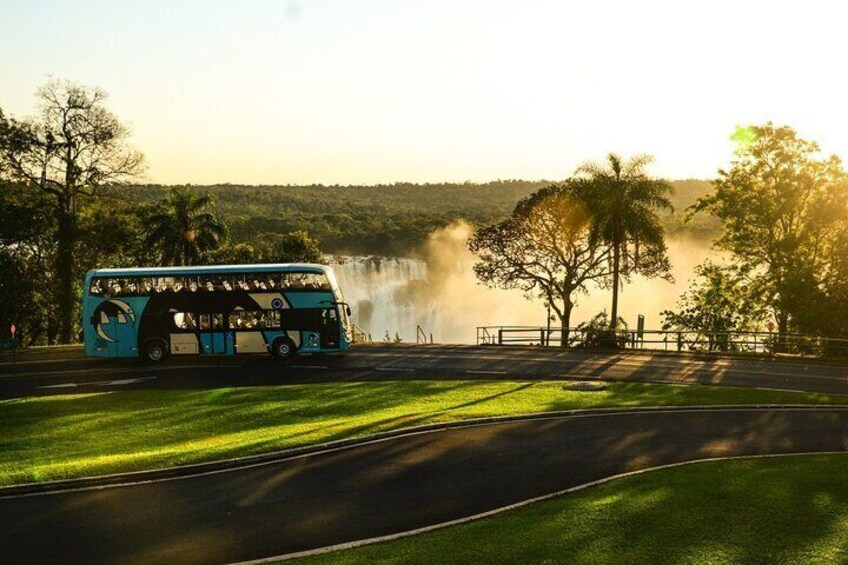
[661,262,763,351]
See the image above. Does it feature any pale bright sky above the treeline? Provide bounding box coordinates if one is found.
[0,0,848,184]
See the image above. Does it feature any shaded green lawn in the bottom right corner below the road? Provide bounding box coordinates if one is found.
[298,455,848,565]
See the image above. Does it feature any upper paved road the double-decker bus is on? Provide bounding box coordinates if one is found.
[0,346,848,398]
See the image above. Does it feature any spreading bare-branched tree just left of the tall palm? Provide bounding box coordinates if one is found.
[468,183,610,347]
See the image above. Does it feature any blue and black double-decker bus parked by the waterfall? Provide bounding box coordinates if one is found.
[82,263,353,363]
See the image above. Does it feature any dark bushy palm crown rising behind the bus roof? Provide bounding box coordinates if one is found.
[145,188,226,265]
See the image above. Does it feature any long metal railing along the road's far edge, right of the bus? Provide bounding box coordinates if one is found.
[477,326,848,356]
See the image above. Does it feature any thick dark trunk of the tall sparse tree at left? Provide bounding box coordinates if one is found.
[55,196,77,343]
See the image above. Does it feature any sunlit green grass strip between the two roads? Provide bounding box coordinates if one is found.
[0,381,848,485]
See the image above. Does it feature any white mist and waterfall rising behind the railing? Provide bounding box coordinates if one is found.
[332,222,711,343]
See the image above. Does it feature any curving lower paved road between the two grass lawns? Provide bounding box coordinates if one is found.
[0,408,848,563]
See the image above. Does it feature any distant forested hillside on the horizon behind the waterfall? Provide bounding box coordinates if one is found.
[104,180,715,256]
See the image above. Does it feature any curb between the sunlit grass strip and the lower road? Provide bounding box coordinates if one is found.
[0,404,848,499]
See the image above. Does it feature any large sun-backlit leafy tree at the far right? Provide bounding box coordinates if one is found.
[692,123,846,337]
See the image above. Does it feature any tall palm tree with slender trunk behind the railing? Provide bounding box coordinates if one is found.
[576,153,673,331]
